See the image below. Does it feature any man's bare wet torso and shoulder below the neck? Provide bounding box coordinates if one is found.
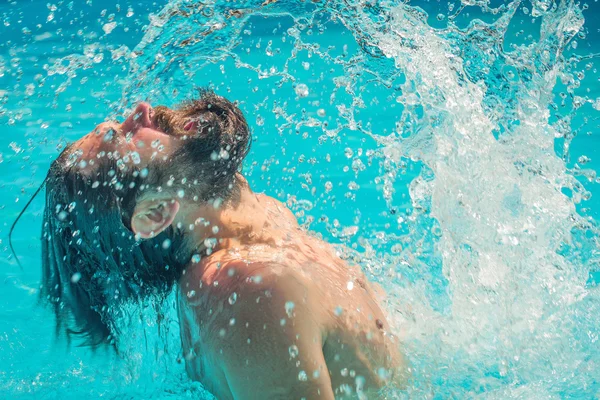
[180,198,402,399]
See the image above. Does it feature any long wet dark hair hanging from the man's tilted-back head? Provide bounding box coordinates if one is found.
[40,158,191,346]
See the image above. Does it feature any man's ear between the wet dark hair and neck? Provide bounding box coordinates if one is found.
[131,199,179,239]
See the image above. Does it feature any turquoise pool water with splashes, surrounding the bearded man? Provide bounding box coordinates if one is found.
[0,0,600,399]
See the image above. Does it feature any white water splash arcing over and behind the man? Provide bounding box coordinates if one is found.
[117,1,599,398]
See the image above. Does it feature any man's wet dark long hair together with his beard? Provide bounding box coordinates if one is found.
[40,91,250,346]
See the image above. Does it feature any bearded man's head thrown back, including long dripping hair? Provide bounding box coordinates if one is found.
[41,91,250,344]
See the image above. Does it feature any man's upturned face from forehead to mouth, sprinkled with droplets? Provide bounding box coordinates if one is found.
[71,103,196,174]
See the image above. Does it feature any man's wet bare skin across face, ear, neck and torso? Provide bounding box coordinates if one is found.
[74,103,404,399]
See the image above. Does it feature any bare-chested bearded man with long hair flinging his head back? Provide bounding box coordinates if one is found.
[42,91,403,399]
